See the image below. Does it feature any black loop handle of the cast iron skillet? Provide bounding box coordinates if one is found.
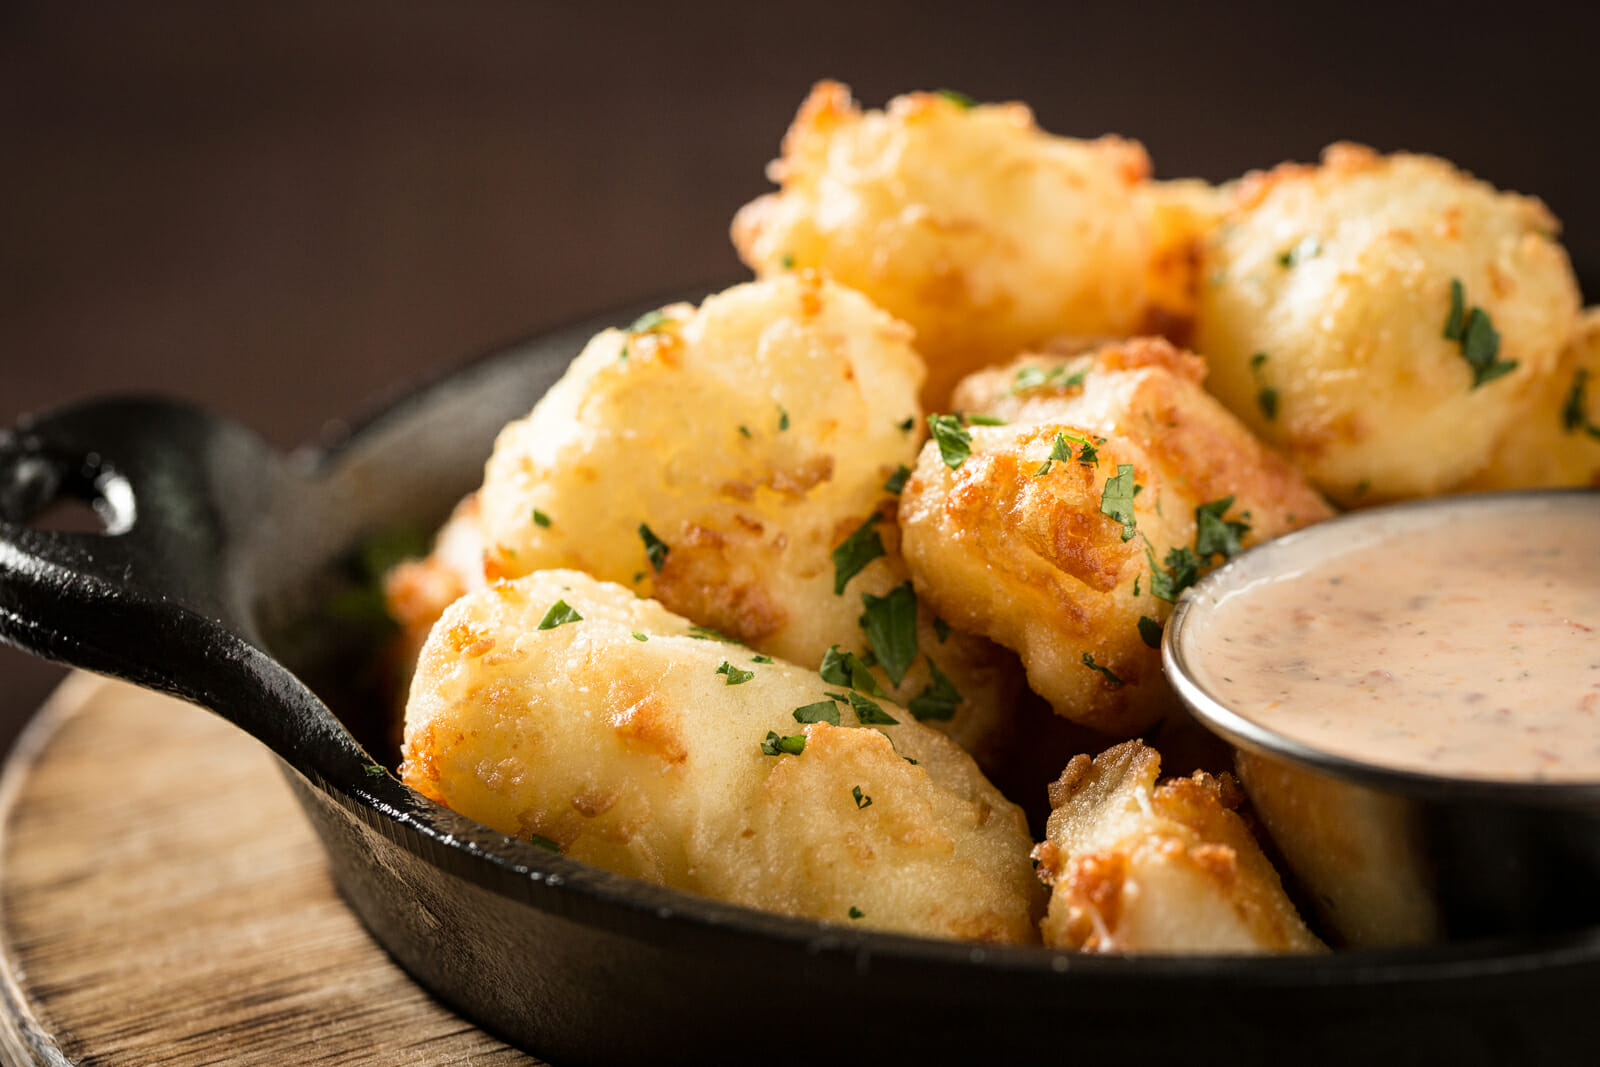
[0,398,370,777]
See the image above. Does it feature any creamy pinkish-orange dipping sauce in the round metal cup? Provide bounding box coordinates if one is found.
[1182,494,1600,782]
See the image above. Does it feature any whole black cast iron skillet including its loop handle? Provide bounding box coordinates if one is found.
[0,302,1600,1064]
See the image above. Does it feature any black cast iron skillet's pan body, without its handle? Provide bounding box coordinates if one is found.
[228,295,1600,1062]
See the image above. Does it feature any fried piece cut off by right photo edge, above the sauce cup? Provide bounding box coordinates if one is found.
[1466,307,1600,490]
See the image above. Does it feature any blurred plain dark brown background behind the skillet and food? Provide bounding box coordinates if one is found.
[0,0,1600,747]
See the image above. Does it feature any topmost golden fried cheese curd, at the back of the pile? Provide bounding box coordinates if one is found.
[733,82,1186,408]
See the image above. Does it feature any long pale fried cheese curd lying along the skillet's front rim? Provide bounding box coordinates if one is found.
[400,571,1042,942]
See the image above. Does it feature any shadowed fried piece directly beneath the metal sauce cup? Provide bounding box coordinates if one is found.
[1234,752,1442,947]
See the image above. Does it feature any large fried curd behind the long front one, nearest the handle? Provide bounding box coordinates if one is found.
[480,272,1022,777]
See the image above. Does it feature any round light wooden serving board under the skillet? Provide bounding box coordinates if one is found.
[0,675,539,1067]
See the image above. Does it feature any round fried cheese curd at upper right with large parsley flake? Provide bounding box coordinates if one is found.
[1194,144,1579,506]
